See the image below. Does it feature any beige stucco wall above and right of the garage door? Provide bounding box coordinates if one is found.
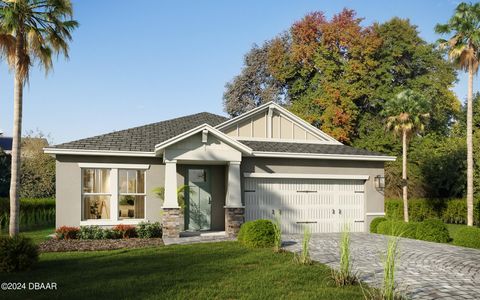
[241,157,384,230]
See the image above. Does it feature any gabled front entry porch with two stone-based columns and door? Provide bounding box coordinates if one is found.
[156,125,251,238]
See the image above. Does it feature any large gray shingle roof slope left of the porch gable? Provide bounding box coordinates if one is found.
[52,112,227,152]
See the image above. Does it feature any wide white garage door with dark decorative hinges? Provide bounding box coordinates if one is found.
[244,178,365,233]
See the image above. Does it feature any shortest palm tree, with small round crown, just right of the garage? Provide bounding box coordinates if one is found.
[382,90,429,222]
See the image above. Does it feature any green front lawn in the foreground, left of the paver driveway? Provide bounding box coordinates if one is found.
[0,242,364,299]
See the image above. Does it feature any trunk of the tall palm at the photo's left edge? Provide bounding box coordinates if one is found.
[9,35,23,236]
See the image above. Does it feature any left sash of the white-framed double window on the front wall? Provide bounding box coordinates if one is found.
[82,169,111,220]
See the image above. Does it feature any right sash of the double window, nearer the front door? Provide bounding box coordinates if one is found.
[118,170,145,220]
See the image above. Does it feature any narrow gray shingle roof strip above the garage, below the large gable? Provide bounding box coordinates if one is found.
[241,141,388,156]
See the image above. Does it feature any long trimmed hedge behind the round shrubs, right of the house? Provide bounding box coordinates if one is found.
[385,199,480,225]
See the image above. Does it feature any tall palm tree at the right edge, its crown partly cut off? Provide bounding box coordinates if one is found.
[435,3,480,226]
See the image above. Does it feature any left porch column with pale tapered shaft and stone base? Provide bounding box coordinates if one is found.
[162,160,181,238]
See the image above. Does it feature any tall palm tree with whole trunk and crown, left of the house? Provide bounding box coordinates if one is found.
[0,0,78,236]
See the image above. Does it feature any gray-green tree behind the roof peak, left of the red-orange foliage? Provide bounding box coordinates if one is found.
[223,43,284,117]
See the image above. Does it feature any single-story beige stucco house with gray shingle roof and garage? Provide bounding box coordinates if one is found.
[45,102,395,237]
